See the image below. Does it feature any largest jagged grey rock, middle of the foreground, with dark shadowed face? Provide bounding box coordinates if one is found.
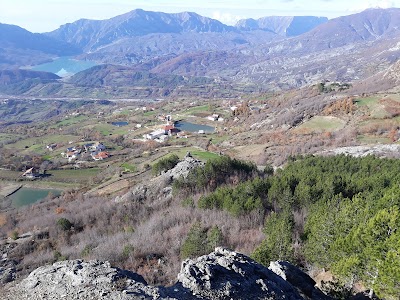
[178,248,303,300]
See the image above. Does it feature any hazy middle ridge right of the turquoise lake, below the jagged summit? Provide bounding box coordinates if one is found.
[79,30,276,67]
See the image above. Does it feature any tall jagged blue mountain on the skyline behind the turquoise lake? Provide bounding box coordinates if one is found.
[47,9,237,51]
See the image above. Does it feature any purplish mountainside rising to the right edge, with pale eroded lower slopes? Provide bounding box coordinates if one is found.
[152,9,400,89]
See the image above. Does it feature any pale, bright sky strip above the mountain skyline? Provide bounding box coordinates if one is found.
[0,0,400,32]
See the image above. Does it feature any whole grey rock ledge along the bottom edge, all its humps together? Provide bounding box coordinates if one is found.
[2,248,330,300]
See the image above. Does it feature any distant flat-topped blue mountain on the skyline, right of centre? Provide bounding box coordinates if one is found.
[236,16,328,37]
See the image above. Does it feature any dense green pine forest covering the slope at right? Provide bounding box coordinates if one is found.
[192,156,400,299]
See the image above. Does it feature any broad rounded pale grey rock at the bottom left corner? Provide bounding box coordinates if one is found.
[6,260,157,300]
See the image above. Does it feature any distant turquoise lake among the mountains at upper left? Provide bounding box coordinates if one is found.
[32,57,97,77]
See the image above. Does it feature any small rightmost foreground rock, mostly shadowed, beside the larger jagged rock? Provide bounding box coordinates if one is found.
[268,260,331,300]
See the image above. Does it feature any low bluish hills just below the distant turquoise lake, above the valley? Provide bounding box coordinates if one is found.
[0,64,259,99]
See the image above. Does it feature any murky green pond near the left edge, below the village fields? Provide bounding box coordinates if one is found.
[9,187,61,208]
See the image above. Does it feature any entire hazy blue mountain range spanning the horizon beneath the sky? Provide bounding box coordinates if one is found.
[0,8,400,95]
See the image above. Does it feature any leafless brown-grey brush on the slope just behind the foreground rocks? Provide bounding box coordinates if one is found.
[0,184,263,284]
